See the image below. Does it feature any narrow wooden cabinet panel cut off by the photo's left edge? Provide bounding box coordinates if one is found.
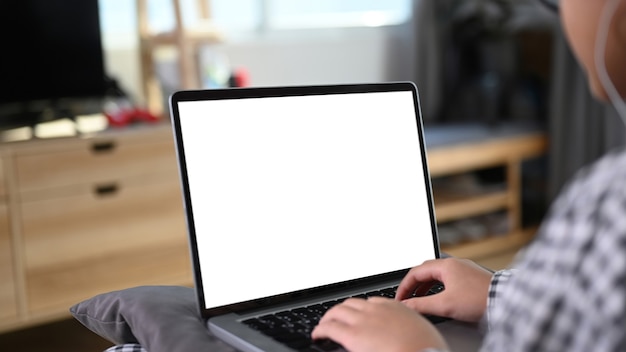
[0,203,17,321]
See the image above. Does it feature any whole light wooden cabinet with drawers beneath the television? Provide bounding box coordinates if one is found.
[0,124,193,330]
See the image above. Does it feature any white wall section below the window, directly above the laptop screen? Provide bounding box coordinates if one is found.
[210,27,411,85]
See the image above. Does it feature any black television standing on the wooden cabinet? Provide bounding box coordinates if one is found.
[0,0,106,129]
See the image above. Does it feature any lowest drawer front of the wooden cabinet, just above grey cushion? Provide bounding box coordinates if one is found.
[26,242,193,315]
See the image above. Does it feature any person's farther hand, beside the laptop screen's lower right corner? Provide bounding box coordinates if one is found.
[396,258,493,322]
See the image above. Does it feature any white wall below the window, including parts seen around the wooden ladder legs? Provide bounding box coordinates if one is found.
[104,24,413,104]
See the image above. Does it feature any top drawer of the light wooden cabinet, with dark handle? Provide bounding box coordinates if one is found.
[15,138,178,193]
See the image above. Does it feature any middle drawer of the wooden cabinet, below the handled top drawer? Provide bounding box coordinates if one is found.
[21,179,187,270]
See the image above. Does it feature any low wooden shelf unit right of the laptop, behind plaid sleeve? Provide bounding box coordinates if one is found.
[428,132,548,260]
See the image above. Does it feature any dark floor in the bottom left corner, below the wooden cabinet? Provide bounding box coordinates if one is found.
[0,319,113,352]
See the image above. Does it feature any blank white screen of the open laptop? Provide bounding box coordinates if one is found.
[179,91,435,308]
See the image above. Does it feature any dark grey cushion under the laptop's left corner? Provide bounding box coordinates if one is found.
[70,286,234,352]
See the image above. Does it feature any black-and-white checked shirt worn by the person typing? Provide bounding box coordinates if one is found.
[482,151,626,352]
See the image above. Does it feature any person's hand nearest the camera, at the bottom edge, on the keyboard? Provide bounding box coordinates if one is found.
[312,297,447,352]
